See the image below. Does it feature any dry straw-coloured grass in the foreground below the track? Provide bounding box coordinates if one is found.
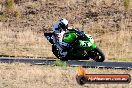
[0,63,132,88]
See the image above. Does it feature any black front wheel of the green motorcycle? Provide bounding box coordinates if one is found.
[92,47,105,62]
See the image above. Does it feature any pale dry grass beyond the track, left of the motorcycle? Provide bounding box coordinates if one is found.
[0,29,53,58]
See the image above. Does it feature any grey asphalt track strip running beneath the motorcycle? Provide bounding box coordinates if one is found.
[0,58,132,70]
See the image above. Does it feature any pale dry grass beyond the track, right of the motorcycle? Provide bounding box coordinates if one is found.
[96,30,132,60]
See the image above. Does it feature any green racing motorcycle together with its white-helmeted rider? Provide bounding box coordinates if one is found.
[44,19,105,62]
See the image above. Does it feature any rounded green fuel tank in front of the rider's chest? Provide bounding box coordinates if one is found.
[63,33,77,43]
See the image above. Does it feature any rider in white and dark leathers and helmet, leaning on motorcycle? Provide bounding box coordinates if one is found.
[52,18,89,58]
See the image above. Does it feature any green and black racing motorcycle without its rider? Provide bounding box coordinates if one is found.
[44,29,105,62]
